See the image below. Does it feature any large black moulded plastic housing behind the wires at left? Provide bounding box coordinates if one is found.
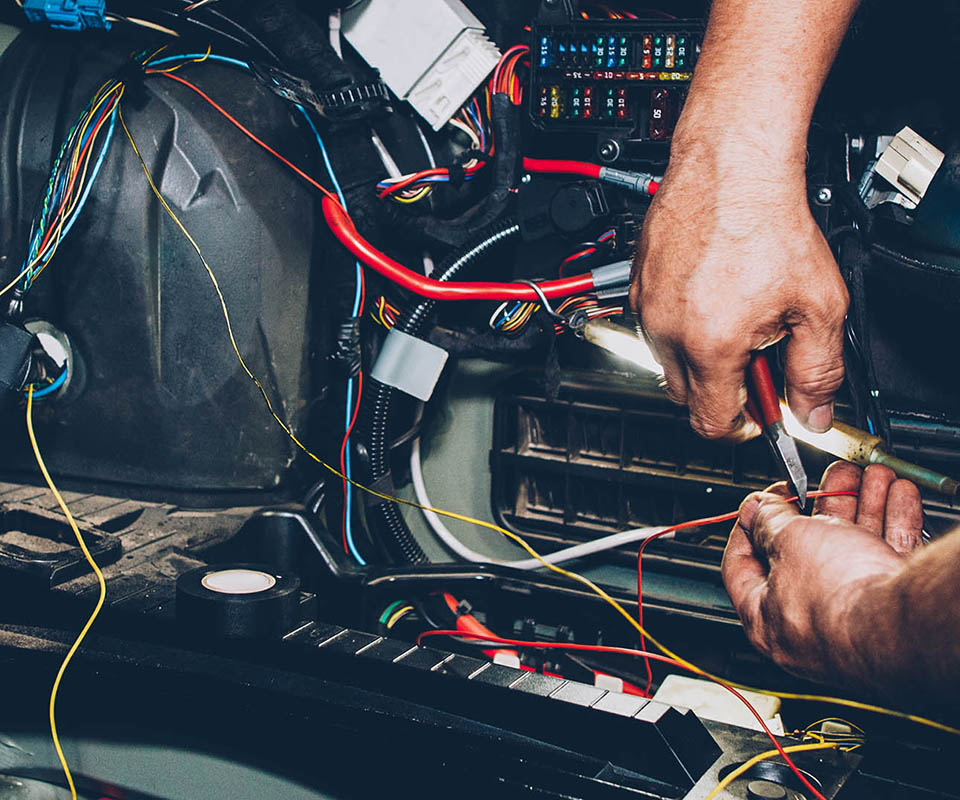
[0,30,324,504]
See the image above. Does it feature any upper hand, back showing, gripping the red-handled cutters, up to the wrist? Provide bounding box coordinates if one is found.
[630,145,848,438]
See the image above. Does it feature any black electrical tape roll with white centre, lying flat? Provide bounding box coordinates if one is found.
[177,564,300,639]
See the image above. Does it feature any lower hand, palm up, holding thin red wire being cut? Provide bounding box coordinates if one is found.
[723,462,923,682]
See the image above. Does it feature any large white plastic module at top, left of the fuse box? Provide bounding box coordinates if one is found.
[343,0,500,131]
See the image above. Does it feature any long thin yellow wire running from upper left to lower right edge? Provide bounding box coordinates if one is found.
[119,103,960,736]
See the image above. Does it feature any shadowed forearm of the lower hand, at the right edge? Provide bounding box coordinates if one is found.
[844,532,960,711]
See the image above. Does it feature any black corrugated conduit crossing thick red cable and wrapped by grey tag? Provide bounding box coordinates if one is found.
[358,220,520,564]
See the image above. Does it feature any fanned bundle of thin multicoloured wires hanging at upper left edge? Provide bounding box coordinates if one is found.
[0,73,123,304]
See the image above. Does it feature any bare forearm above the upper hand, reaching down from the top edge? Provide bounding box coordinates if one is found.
[674,0,859,170]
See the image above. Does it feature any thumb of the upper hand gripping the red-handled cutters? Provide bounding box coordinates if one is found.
[784,301,846,433]
